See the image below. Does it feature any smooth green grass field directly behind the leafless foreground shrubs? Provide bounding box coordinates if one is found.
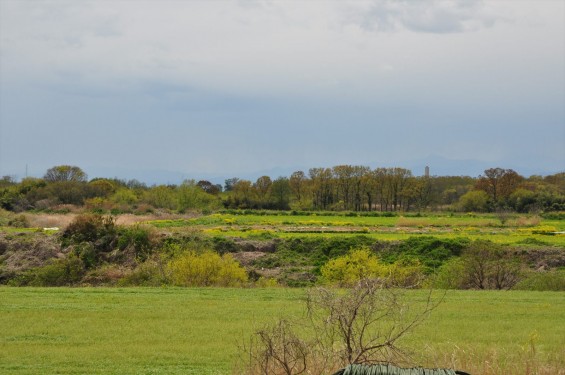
[0,287,565,375]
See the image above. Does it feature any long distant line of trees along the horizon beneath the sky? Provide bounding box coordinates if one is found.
[0,165,565,213]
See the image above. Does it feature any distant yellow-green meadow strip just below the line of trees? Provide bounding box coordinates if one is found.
[147,213,565,247]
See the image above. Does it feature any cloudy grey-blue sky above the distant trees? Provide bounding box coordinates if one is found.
[0,0,565,183]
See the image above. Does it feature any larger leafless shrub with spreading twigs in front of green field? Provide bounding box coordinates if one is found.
[307,280,439,364]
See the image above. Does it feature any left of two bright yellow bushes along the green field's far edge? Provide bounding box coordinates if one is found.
[167,251,247,286]
